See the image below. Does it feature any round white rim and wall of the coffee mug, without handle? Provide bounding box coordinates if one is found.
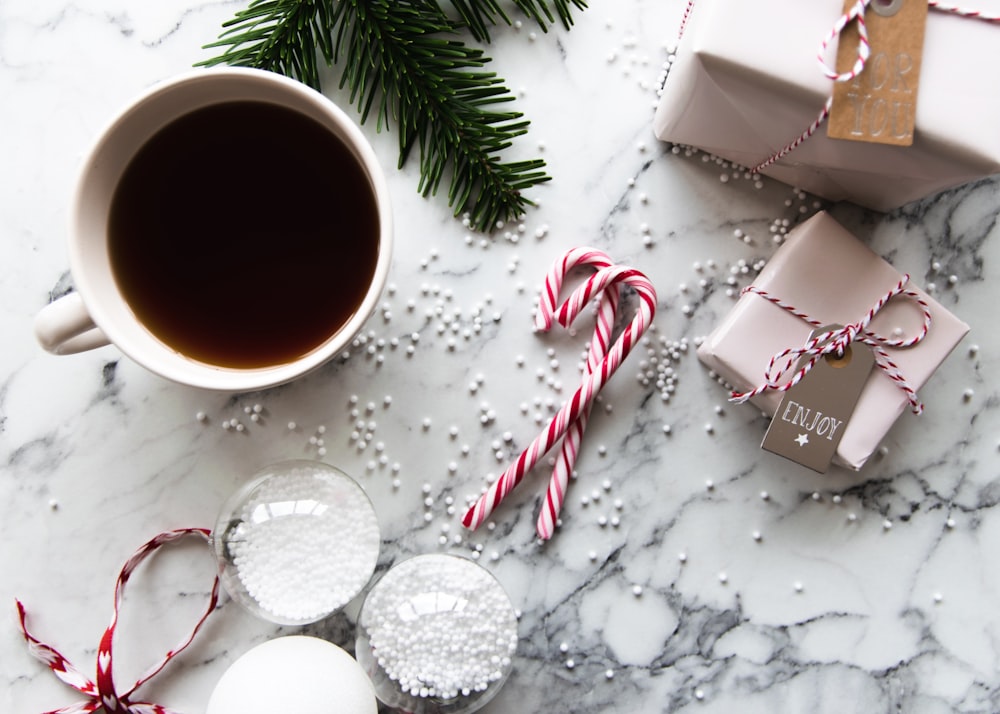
[69,67,393,391]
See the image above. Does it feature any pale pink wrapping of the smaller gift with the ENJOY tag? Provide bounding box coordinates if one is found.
[698,212,969,470]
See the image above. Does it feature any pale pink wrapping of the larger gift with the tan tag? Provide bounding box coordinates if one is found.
[653,0,1000,211]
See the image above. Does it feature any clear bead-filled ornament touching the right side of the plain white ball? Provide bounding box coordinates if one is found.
[357,554,517,714]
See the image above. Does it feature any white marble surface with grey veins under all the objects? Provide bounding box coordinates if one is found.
[0,0,1000,714]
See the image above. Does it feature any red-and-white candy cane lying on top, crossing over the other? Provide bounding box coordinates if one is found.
[462,266,656,530]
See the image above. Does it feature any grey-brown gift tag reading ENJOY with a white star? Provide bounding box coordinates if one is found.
[760,325,875,473]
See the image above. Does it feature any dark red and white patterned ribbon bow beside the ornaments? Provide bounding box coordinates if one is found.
[15,528,219,714]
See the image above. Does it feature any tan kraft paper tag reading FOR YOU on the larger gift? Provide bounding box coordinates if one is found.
[827,0,927,146]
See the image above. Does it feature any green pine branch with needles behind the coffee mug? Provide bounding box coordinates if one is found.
[199,0,586,230]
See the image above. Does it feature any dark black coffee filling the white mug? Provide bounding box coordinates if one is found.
[108,101,380,369]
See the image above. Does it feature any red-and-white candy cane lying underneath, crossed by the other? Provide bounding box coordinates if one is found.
[535,247,619,540]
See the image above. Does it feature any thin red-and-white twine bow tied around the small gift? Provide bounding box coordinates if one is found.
[730,275,931,414]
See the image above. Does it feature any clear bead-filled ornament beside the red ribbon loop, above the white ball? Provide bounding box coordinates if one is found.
[214,460,381,625]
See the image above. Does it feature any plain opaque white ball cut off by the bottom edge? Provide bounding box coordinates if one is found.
[206,635,378,714]
